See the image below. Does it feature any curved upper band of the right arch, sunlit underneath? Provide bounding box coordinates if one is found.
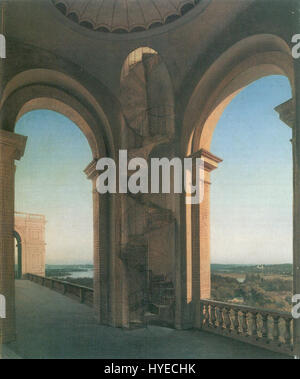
[182,34,295,155]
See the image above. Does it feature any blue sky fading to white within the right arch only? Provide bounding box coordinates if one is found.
[211,76,292,263]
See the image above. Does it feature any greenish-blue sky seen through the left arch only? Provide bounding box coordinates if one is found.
[16,110,93,264]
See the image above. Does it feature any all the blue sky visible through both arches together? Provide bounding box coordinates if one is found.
[16,76,292,264]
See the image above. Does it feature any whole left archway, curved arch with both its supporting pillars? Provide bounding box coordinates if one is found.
[0,70,123,341]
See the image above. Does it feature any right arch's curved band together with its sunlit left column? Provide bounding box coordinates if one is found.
[181,34,295,324]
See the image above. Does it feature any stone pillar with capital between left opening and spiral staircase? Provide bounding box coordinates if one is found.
[85,160,110,325]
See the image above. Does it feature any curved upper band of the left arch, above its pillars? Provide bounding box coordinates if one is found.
[0,69,114,158]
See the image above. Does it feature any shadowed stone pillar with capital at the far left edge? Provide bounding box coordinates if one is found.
[0,130,27,343]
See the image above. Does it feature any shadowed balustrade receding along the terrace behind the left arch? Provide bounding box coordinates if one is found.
[24,274,94,307]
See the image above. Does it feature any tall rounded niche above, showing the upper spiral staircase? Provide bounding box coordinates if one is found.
[120,46,175,142]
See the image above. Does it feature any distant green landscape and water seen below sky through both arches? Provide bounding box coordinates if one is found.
[46,264,293,312]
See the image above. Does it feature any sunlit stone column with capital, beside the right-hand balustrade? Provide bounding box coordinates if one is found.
[188,149,222,328]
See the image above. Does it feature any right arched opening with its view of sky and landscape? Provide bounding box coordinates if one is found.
[210,76,293,312]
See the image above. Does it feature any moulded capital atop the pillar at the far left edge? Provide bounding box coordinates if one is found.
[0,130,27,160]
